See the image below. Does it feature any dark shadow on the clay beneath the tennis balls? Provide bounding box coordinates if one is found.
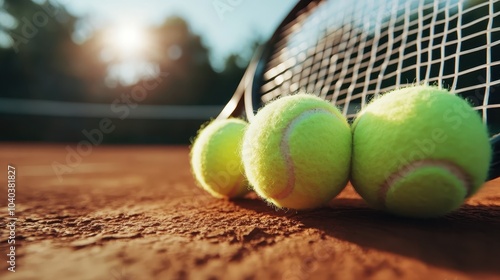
[290,199,500,274]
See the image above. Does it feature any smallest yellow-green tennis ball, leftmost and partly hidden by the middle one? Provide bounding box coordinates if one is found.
[191,119,248,198]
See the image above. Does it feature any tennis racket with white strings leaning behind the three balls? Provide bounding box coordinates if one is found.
[218,0,500,180]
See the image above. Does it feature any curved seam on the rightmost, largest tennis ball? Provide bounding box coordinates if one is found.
[378,159,474,207]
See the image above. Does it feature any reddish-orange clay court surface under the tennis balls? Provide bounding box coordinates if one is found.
[0,144,500,280]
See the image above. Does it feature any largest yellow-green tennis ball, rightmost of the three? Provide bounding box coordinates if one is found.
[351,85,491,218]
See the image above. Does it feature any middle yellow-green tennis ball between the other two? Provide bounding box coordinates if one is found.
[242,94,352,210]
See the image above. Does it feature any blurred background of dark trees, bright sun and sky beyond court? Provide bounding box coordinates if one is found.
[0,0,297,144]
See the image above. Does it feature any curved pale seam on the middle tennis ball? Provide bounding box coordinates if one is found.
[270,108,339,199]
